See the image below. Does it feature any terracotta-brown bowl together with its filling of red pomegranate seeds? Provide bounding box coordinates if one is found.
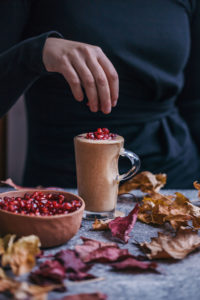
[0,190,85,247]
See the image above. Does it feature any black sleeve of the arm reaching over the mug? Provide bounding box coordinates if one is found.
[0,32,60,117]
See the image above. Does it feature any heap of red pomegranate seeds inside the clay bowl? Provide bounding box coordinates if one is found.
[0,191,81,216]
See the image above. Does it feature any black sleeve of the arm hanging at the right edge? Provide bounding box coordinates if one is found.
[178,0,200,152]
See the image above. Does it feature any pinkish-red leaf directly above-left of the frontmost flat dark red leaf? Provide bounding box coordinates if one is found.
[84,246,129,263]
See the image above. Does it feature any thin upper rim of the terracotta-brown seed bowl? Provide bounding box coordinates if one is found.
[0,189,85,220]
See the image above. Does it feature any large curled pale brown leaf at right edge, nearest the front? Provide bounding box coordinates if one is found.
[140,227,200,259]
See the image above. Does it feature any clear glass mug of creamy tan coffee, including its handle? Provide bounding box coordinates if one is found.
[74,134,140,219]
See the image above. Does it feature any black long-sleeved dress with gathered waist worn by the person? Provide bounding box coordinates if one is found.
[0,0,200,188]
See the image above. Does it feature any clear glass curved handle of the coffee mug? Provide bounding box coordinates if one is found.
[117,148,140,183]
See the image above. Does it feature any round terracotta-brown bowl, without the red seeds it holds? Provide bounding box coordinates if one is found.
[0,189,85,248]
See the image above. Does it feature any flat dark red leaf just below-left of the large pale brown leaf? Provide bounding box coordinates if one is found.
[111,256,158,271]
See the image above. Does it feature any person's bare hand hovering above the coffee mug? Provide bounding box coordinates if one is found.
[43,37,119,114]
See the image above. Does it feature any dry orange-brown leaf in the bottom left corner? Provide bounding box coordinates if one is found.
[0,268,59,300]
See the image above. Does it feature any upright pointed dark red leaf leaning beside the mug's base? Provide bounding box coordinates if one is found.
[108,204,139,243]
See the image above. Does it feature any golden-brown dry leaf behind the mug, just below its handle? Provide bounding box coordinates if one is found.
[119,171,167,195]
